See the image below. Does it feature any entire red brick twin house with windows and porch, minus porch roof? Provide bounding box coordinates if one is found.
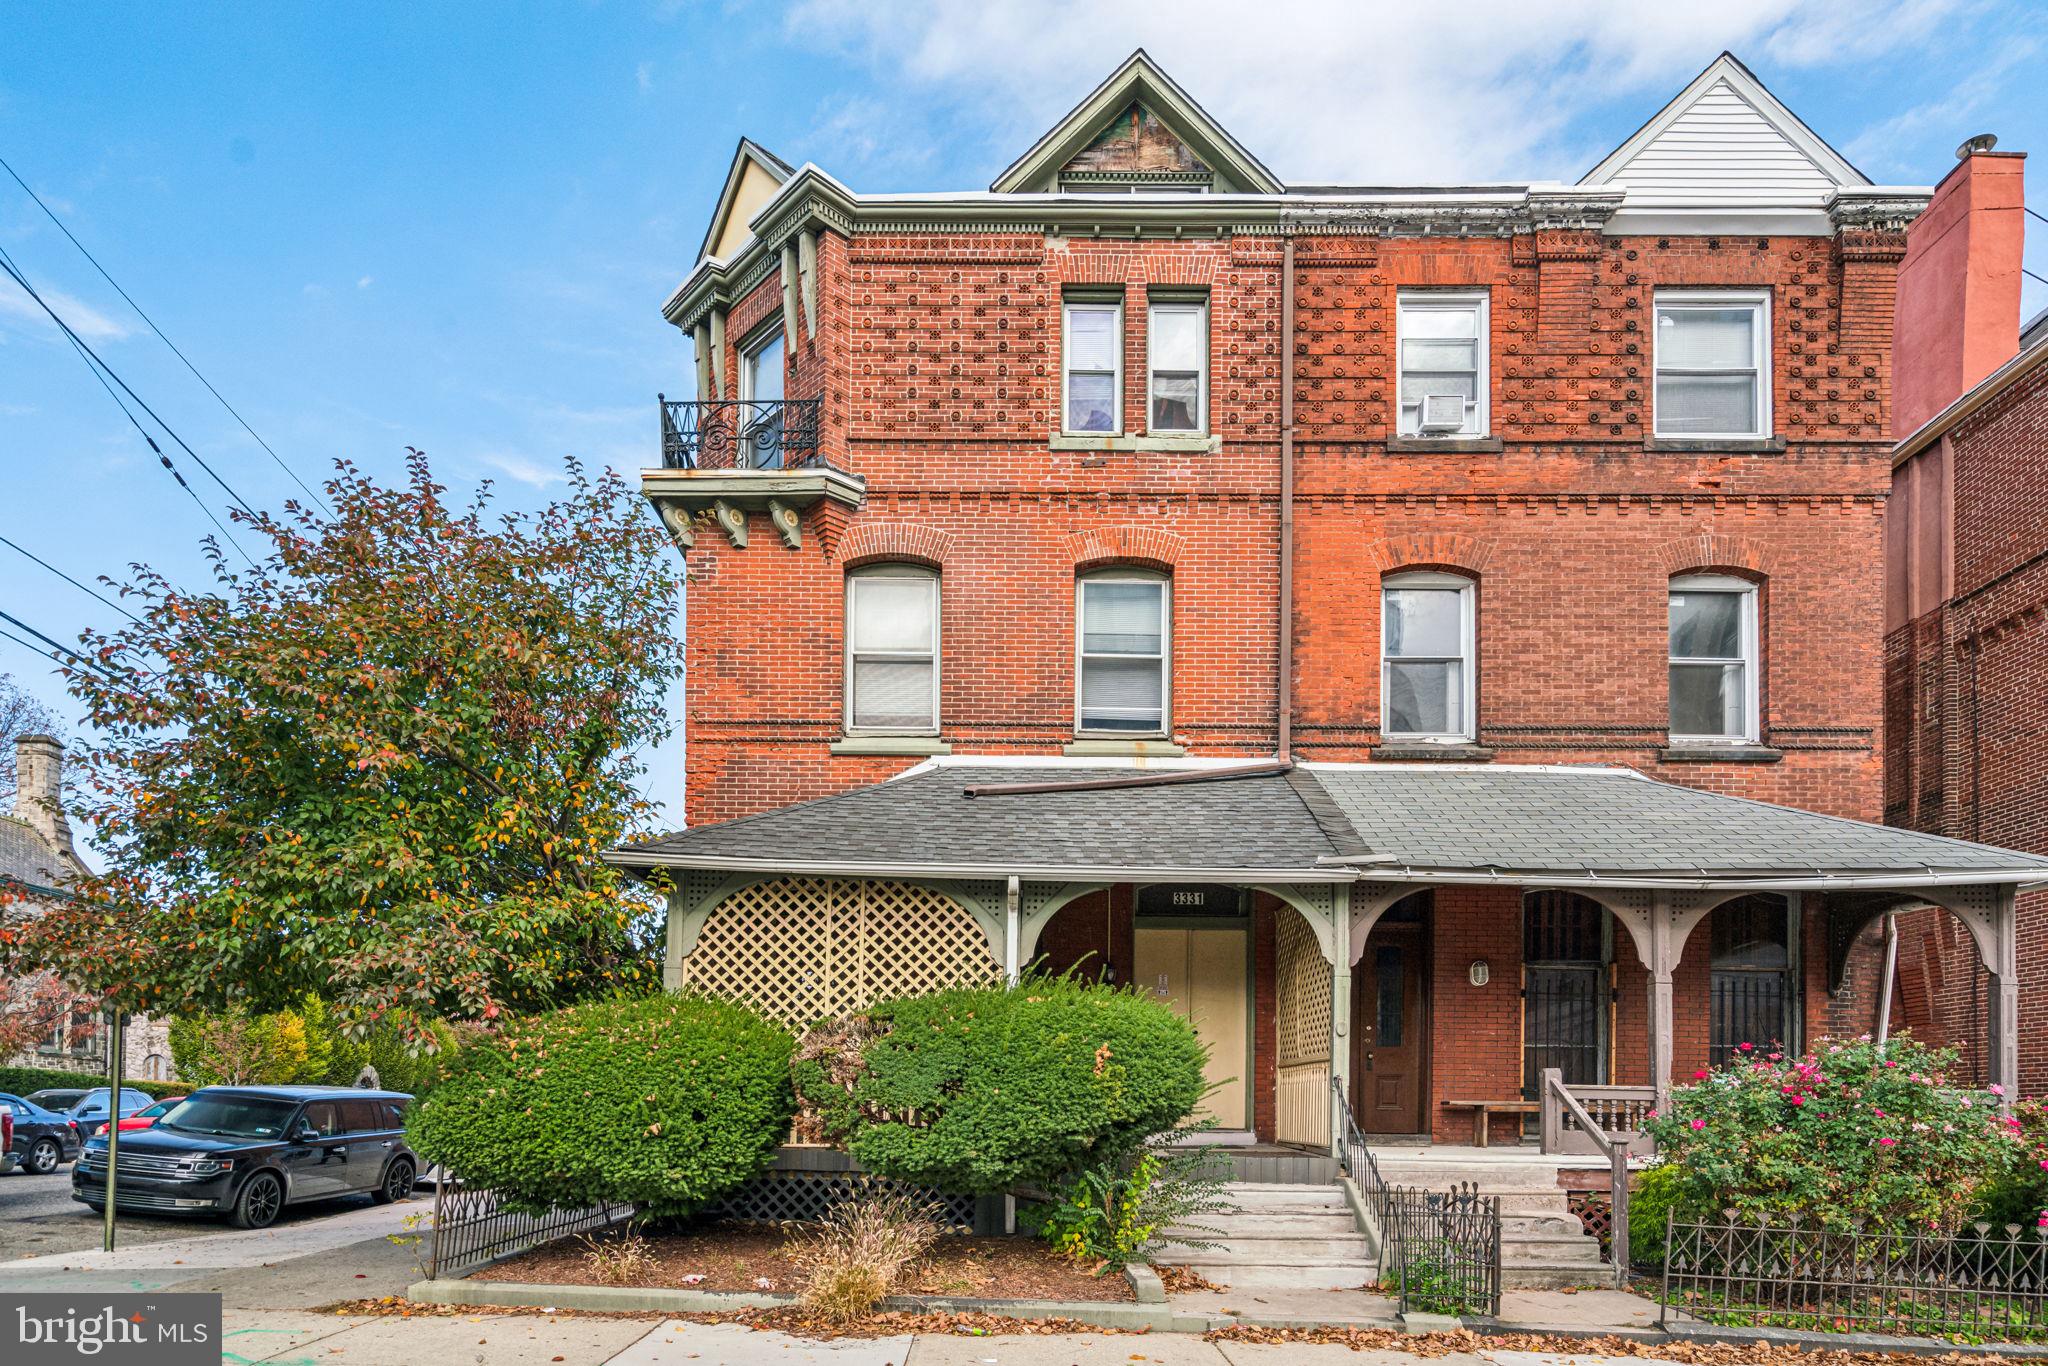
[602,53,2048,1143]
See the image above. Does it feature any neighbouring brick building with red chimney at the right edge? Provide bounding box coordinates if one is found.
[1884,150,2048,1094]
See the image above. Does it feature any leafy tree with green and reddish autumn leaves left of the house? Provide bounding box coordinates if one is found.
[10,451,682,1028]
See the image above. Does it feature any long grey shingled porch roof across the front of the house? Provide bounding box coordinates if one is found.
[608,758,2048,889]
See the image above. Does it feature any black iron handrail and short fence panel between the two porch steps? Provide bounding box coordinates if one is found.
[1329,1077,1501,1317]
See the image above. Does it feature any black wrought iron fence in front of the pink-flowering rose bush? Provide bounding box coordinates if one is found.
[1659,1219,2048,1341]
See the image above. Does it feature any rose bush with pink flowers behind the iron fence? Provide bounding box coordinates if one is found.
[1647,1036,2021,1233]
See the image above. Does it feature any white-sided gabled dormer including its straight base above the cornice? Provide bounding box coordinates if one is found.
[1579,53,1870,233]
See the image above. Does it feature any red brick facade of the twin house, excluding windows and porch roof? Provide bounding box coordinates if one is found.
[647,55,1949,1139]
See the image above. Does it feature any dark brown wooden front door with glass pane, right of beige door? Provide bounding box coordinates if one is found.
[1352,925,1430,1135]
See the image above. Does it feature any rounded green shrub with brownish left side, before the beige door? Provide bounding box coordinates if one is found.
[799,977,1208,1194]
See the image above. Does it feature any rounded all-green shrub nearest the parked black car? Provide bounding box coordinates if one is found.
[406,995,793,1216]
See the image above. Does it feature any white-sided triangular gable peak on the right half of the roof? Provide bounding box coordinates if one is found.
[1579,51,1870,203]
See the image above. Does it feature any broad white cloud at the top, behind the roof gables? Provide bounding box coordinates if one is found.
[786,0,1962,182]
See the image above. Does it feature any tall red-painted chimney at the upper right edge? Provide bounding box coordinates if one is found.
[1892,139,2025,438]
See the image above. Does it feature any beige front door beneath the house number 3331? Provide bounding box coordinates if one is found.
[1135,924,1251,1128]
